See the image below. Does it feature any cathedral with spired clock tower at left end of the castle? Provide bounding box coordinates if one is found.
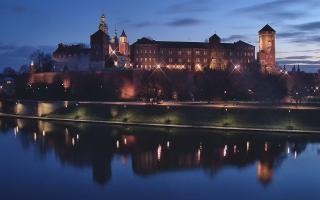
[53,15,130,71]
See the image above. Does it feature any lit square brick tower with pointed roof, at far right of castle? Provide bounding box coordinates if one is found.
[258,24,277,73]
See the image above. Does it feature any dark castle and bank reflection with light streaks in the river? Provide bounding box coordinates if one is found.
[0,118,320,186]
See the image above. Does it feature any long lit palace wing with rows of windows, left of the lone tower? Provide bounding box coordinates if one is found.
[131,34,255,71]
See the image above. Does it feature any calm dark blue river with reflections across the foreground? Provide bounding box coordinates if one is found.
[0,118,320,200]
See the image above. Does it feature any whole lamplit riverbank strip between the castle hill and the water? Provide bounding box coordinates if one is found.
[1,101,320,134]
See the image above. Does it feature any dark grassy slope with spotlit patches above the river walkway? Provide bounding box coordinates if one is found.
[48,105,320,130]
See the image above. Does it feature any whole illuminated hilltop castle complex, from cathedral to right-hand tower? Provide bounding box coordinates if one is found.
[53,15,279,73]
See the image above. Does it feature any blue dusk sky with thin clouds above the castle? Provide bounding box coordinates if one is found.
[0,0,320,71]
